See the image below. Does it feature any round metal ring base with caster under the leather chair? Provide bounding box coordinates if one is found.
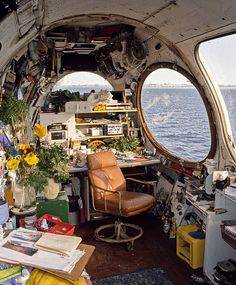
[94,221,143,249]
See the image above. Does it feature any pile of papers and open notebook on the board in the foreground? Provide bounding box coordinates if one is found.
[0,228,85,273]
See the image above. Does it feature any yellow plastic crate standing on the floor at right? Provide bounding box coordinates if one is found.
[176,225,205,269]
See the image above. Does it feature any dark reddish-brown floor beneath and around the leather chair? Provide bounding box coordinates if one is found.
[77,215,203,285]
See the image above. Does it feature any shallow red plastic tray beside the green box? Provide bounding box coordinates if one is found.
[35,214,75,236]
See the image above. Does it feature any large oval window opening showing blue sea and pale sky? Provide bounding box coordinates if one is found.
[141,68,211,161]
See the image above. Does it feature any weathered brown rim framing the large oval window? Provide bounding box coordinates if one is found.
[137,62,217,167]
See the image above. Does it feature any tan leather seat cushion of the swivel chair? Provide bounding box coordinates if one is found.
[95,191,155,217]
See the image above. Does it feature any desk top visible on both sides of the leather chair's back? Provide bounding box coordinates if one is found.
[69,158,160,173]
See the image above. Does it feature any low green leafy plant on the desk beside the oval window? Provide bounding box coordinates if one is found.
[108,136,141,152]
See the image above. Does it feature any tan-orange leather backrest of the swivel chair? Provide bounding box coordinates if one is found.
[87,152,126,200]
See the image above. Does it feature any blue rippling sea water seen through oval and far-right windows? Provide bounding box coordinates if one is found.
[141,87,236,160]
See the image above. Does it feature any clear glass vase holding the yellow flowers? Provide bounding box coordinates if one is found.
[14,184,36,209]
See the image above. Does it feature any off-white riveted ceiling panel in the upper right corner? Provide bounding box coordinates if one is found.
[145,0,236,43]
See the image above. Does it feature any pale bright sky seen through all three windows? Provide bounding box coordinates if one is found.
[54,35,236,88]
